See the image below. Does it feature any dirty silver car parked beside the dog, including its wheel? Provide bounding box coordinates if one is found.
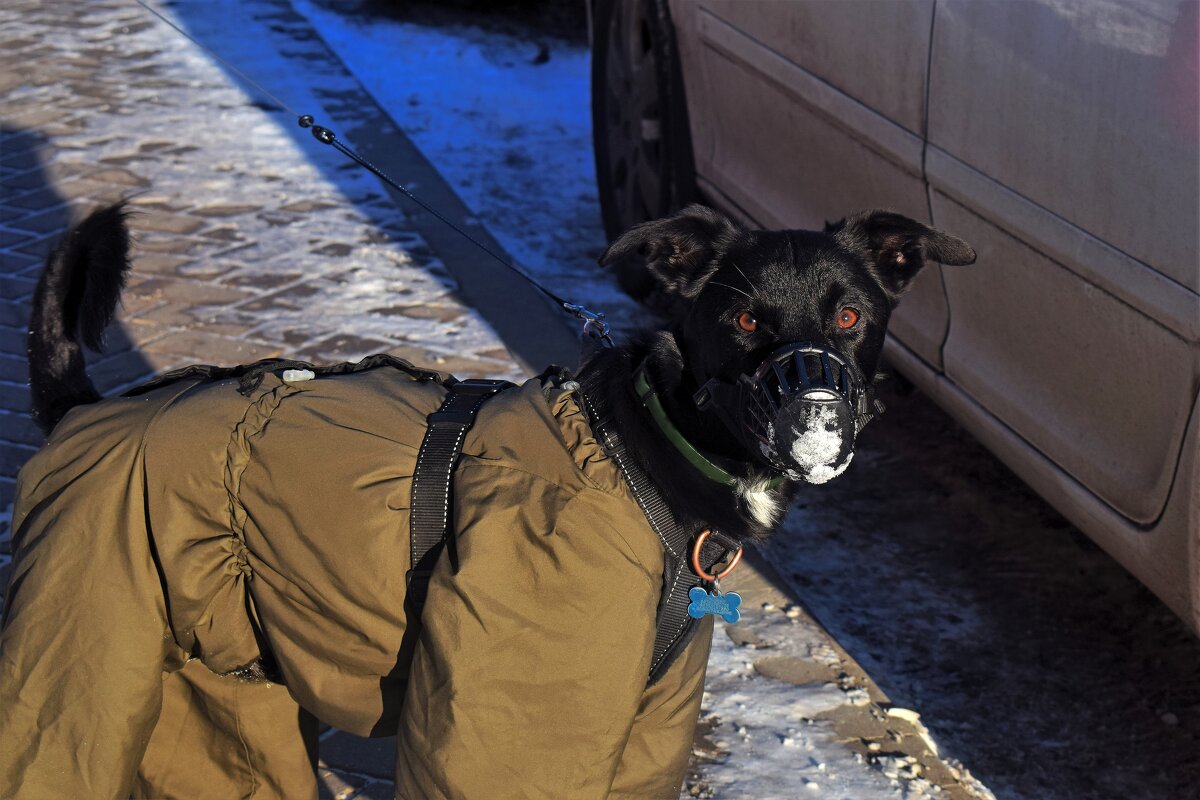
[590,0,1200,631]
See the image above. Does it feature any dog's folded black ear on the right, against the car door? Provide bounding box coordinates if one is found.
[826,211,976,302]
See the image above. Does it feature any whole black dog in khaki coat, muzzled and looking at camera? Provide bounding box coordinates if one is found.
[9,206,974,798]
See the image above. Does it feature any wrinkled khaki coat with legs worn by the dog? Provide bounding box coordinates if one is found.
[0,362,712,800]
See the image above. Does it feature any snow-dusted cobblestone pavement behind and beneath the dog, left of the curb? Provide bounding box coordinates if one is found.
[0,0,549,798]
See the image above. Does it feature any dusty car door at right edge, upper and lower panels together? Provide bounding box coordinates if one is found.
[925,0,1200,524]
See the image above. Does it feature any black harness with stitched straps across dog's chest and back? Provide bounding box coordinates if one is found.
[407,380,739,685]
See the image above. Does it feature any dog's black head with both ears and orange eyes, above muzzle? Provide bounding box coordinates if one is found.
[601,205,976,482]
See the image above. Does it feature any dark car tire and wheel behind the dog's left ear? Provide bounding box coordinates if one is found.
[592,0,696,300]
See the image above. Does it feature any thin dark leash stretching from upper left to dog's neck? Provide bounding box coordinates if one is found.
[133,0,613,347]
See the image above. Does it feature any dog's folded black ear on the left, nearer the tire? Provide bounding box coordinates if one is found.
[600,205,746,300]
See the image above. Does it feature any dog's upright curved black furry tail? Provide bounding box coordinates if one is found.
[29,201,130,434]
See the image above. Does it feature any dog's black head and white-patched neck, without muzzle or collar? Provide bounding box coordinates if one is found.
[581,206,976,540]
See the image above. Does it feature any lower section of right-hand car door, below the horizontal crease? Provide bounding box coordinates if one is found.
[932,192,1198,524]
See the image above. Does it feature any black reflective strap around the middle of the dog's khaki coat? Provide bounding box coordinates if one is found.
[404,380,514,609]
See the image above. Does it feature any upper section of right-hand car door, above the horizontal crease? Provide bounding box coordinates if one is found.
[929,0,1200,293]
